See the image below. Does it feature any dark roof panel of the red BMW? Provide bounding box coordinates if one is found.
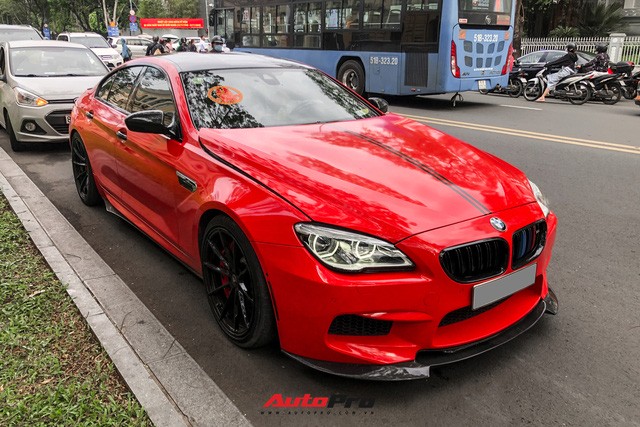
[136,52,311,72]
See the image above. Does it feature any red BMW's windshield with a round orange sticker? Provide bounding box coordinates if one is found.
[181,68,378,129]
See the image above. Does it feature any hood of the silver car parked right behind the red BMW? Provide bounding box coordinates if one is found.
[14,76,106,100]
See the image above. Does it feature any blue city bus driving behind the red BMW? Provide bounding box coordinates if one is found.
[209,0,515,95]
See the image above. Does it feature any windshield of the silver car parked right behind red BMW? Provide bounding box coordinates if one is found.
[10,47,108,77]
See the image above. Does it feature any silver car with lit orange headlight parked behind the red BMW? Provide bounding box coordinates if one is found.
[0,40,109,151]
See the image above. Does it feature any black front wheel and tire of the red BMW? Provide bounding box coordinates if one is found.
[200,215,276,348]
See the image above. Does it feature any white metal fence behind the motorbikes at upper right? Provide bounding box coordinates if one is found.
[520,34,640,64]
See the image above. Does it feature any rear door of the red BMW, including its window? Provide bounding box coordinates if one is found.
[81,66,144,202]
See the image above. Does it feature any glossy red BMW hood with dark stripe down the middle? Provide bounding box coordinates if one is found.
[200,114,535,242]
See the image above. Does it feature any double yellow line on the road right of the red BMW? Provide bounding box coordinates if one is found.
[404,114,640,154]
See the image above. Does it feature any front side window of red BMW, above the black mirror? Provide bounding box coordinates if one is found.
[131,67,176,126]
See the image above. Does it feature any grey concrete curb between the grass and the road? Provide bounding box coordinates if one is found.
[0,148,251,426]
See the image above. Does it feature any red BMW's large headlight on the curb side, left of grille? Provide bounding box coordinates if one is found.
[294,223,414,273]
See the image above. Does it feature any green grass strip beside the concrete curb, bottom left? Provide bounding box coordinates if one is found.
[0,192,152,426]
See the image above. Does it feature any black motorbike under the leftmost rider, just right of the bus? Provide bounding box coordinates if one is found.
[524,67,590,105]
